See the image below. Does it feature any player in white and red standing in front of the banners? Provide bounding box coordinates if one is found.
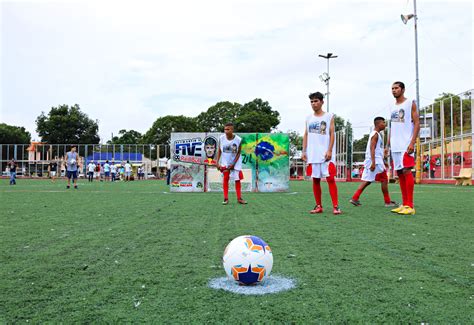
[216,123,247,205]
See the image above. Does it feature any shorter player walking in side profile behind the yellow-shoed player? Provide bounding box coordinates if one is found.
[349,117,397,207]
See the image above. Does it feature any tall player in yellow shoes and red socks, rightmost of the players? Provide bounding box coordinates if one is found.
[385,81,420,215]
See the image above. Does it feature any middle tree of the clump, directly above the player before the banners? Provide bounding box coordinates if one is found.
[196,101,242,132]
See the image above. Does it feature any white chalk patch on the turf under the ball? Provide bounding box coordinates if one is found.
[209,275,296,295]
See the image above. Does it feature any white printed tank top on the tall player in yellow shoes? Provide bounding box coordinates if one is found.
[390,98,413,152]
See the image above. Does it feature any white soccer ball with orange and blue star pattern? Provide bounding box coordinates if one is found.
[222,235,273,285]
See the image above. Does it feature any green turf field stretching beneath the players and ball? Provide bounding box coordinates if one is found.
[0,179,474,324]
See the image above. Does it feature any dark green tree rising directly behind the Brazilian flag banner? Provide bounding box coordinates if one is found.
[234,98,280,133]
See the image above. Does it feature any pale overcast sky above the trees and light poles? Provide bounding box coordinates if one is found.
[0,0,474,141]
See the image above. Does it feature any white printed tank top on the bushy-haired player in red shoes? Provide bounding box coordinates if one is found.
[306,112,336,164]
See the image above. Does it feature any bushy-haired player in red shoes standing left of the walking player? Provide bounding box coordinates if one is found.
[302,91,342,215]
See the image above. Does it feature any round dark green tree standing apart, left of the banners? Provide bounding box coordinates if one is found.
[36,104,100,144]
